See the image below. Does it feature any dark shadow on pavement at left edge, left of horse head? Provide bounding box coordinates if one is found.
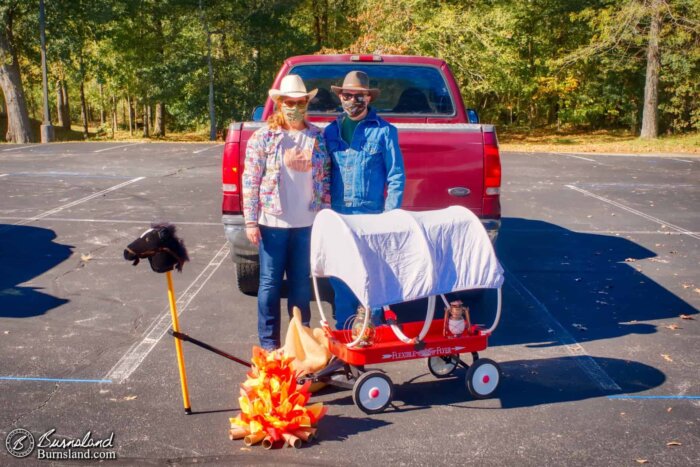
[0,224,73,318]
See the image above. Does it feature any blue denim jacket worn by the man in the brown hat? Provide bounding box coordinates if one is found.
[324,107,406,214]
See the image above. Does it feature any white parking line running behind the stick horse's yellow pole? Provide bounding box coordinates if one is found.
[105,242,229,384]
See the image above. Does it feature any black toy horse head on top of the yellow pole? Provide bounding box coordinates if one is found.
[124,224,190,272]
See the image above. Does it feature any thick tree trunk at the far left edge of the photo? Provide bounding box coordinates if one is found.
[0,2,32,143]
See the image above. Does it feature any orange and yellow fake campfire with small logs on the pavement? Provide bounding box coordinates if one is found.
[229,346,328,449]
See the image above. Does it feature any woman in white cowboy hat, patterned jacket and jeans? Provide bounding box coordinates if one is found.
[243,75,331,350]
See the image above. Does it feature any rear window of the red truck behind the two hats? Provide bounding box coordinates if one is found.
[289,63,455,116]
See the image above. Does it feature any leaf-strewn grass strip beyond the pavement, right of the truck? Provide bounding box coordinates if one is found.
[498,130,700,155]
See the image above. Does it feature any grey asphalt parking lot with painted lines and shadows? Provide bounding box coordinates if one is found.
[0,143,700,466]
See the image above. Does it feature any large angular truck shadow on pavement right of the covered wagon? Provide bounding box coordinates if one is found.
[494,218,697,345]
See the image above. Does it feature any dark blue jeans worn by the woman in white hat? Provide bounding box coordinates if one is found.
[258,225,311,350]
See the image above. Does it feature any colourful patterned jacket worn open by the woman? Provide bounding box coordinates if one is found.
[242,122,331,223]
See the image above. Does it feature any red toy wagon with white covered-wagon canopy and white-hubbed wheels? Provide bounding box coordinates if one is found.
[308,206,503,413]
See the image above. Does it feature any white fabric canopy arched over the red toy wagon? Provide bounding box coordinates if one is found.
[311,206,503,308]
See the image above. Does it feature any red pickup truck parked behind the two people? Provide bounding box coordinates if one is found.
[222,55,501,294]
